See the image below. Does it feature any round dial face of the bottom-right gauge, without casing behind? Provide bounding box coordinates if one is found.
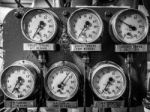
[92,66,126,100]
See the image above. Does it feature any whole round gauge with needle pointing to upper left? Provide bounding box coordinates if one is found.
[110,9,149,44]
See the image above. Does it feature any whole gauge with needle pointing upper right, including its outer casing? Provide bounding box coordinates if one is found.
[45,61,80,101]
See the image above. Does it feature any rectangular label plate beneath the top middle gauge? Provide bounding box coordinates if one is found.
[70,44,101,51]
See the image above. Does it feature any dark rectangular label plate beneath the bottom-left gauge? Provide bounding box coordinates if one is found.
[4,100,36,108]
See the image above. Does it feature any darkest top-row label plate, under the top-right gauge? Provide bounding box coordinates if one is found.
[115,44,147,52]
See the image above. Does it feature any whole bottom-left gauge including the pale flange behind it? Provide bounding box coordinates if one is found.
[1,60,40,100]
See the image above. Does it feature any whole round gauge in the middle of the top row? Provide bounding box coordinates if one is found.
[67,9,103,43]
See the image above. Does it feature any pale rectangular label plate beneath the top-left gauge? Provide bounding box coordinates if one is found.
[23,43,55,51]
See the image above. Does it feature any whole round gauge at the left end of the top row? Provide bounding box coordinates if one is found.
[21,9,58,43]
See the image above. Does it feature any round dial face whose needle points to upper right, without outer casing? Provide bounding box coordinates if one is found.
[47,67,78,100]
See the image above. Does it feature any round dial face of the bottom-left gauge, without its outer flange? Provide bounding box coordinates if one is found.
[2,66,35,100]
